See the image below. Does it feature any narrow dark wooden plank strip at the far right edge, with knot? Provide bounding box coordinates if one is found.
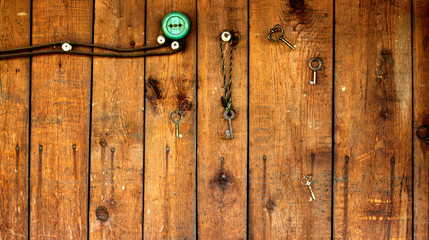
[413,0,429,239]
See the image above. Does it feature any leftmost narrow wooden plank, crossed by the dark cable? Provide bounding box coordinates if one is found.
[0,0,30,239]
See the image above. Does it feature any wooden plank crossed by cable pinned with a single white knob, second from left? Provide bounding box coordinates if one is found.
[30,0,93,239]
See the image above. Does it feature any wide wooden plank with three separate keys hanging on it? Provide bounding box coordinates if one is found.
[249,0,333,239]
